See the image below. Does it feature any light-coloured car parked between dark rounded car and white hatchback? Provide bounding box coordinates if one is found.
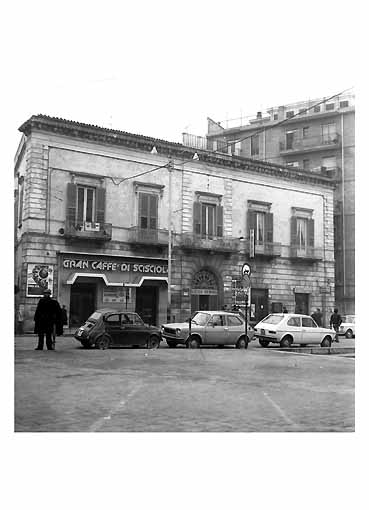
[161,311,254,349]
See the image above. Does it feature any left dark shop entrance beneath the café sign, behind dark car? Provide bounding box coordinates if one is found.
[69,282,96,327]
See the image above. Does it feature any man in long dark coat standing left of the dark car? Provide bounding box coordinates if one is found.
[34,289,63,351]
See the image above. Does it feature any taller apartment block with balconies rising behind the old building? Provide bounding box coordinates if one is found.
[187,94,355,314]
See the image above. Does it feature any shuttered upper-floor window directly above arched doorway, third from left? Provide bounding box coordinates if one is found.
[193,192,223,239]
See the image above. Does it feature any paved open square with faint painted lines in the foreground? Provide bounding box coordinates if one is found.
[15,336,355,432]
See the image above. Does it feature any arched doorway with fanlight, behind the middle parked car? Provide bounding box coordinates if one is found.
[191,269,219,313]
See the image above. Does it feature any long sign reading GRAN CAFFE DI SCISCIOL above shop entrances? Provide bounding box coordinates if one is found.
[63,259,168,275]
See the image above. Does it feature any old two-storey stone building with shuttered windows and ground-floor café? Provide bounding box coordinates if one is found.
[14,115,335,331]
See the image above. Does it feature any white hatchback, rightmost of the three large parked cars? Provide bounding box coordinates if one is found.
[254,313,335,347]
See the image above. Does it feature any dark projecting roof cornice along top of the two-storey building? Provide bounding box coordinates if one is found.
[19,115,335,188]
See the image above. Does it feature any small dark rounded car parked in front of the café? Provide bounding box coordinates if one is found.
[74,309,161,349]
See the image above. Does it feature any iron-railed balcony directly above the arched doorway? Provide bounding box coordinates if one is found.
[177,232,240,253]
